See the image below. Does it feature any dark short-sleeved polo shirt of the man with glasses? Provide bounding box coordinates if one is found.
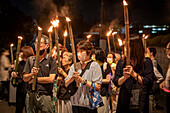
[23,54,57,95]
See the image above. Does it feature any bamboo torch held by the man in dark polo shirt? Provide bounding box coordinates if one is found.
[32,27,42,91]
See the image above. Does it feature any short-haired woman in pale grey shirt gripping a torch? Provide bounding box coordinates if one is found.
[65,40,102,113]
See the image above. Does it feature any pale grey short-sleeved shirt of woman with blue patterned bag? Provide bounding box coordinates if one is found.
[65,62,102,107]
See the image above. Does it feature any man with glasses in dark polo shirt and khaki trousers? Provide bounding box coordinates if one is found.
[23,35,57,113]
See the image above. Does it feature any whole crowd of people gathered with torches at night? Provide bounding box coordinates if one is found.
[0,35,170,113]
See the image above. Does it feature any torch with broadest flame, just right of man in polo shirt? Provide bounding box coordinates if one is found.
[51,20,61,68]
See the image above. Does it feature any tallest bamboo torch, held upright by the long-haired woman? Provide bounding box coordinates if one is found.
[123,0,130,65]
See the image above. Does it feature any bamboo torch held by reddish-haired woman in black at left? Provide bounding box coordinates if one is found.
[12,36,22,84]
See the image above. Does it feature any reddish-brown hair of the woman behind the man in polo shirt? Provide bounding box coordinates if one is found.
[21,46,34,59]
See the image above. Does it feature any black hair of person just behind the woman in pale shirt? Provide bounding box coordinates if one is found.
[94,47,106,63]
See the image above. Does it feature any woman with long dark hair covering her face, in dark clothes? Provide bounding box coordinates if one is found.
[113,35,154,113]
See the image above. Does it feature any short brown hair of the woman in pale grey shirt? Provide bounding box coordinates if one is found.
[76,40,94,57]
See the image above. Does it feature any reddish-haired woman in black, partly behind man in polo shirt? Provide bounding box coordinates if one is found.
[11,46,34,113]
